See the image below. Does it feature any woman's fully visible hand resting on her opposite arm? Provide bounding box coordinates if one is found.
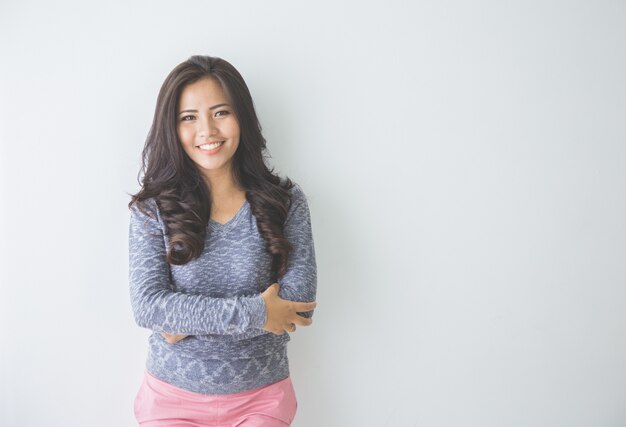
[261,283,317,335]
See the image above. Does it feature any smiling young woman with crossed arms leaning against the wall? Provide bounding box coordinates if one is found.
[129,56,317,427]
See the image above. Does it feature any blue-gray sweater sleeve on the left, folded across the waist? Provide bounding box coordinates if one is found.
[129,199,266,335]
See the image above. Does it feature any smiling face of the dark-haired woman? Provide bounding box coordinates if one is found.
[176,78,240,186]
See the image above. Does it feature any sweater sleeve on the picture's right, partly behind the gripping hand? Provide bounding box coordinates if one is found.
[278,184,317,318]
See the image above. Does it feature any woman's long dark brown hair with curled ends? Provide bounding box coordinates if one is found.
[128,55,294,282]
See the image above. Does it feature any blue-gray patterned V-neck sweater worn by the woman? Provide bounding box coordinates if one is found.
[129,184,317,394]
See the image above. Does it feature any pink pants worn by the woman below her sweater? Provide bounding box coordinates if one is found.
[134,371,298,427]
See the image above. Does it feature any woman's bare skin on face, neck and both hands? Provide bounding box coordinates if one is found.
[161,77,317,344]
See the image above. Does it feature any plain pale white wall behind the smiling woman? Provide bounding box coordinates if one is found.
[0,0,626,427]
